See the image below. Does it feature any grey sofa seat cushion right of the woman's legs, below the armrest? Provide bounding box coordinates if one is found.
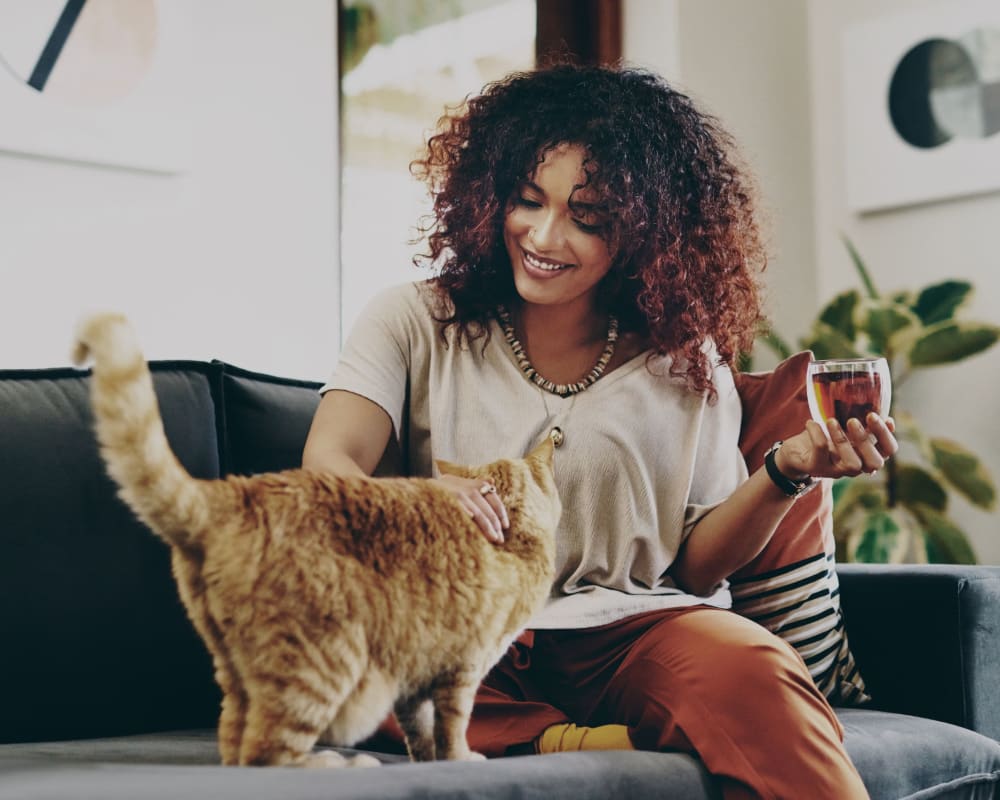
[837,708,1000,800]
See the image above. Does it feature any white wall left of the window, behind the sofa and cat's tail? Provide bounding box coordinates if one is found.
[0,0,340,379]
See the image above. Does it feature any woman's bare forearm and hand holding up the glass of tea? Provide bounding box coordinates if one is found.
[670,414,898,597]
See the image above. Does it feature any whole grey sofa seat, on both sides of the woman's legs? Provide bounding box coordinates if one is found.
[0,709,1000,800]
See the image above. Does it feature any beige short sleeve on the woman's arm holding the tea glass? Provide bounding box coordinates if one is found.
[684,365,747,538]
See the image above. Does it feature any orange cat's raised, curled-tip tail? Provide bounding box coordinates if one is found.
[73,313,208,547]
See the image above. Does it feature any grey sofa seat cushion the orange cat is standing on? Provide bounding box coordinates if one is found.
[0,732,720,800]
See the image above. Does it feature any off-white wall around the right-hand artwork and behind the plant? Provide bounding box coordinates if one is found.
[808,0,1000,564]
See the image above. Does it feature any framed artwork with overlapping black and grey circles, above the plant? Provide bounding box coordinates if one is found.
[843,0,1000,212]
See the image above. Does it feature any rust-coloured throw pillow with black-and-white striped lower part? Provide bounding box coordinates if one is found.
[730,351,869,705]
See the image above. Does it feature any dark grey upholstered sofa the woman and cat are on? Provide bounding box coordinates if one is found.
[0,362,1000,800]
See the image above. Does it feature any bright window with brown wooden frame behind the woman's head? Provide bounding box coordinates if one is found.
[339,0,621,335]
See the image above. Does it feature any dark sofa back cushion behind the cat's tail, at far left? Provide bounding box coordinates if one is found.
[0,362,219,742]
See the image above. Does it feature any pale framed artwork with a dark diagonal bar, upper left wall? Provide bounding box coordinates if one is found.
[0,0,192,173]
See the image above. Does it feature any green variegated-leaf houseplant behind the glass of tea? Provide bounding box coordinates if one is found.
[761,237,1000,563]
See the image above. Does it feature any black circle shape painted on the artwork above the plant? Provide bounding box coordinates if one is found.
[889,39,976,148]
